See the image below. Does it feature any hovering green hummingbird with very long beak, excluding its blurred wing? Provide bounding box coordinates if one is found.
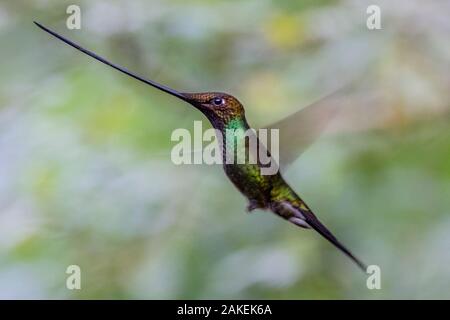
[34,21,367,272]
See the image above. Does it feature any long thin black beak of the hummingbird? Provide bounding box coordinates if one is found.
[33,21,195,106]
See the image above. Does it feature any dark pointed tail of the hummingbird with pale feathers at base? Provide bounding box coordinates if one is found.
[272,202,367,272]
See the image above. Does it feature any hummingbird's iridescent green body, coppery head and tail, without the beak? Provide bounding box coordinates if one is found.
[183,92,366,270]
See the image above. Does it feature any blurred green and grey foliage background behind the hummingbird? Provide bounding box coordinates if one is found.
[0,0,450,299]
